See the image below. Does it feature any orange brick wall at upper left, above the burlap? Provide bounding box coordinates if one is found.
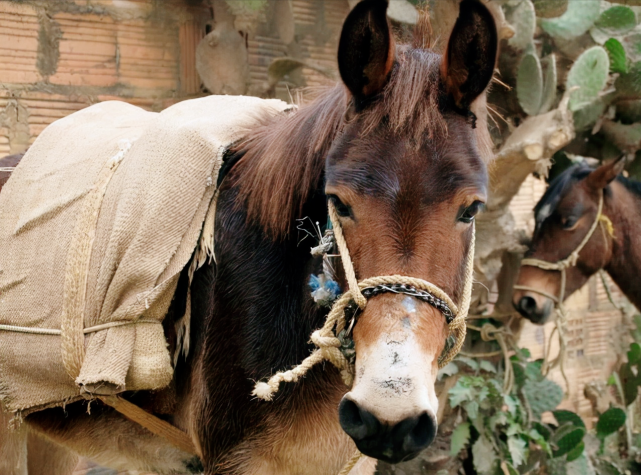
[0,0,205,157]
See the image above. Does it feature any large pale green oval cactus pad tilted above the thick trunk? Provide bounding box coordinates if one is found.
[566,46,610,111]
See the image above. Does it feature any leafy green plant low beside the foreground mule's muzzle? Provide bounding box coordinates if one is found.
[449,350,585,475]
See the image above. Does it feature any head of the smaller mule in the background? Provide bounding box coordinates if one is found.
[512,160,624,325]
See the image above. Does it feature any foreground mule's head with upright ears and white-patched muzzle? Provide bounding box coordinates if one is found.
[325,0,497,463]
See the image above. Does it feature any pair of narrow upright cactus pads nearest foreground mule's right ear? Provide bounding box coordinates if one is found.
[516,52,556,115]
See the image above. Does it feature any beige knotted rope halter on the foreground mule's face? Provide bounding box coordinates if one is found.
[252,200,475,401]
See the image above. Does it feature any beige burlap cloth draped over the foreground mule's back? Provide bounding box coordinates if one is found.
[0,96,289,412]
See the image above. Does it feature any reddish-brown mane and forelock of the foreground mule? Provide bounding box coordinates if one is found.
[233,14,487,237]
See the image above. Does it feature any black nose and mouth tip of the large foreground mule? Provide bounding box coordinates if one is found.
[338,397,438,463]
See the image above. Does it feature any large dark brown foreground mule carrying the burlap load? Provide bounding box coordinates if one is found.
[1,0,497,475]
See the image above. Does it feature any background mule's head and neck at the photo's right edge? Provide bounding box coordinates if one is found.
[513,159,641,324]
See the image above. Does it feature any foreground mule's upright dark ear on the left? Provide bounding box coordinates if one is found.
[338,0,394,100]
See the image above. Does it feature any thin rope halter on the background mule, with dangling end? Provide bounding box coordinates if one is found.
[513,190,614,388]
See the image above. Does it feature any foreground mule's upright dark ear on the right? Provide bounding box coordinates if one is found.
[441,0,498,109]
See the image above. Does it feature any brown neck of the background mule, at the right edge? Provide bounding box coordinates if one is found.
[604,181,641,309]
